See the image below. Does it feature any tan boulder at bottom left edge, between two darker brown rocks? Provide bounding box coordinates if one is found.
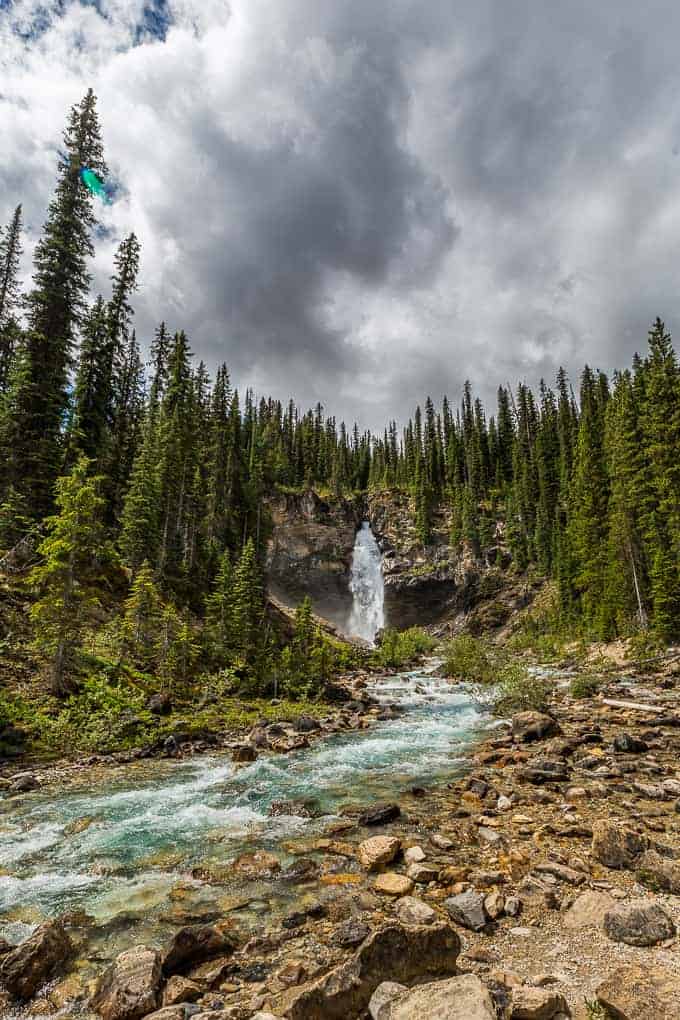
[91,946,161,1020]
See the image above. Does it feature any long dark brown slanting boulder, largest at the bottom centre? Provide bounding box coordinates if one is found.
[272,922,462,1020]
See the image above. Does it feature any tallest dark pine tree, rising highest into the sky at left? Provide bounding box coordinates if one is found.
[0,90,107,517]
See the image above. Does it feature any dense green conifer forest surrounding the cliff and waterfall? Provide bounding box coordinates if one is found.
[0,92,680,718]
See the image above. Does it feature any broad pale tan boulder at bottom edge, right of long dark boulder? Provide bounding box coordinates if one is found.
[371,974,496,1020]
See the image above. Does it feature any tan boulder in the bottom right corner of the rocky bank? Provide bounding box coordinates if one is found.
[596,962,680,1020]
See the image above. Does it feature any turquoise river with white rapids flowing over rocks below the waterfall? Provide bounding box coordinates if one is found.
[0,671,483,969]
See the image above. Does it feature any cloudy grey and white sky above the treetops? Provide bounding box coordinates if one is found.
[0,0,680,426]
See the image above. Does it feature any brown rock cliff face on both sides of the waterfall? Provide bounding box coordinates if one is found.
[267,490,532,631]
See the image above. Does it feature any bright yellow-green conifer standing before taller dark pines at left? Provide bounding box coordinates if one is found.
[30,457,113,697]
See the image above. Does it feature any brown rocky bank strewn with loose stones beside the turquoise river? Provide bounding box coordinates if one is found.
[0,656,680,1020]
